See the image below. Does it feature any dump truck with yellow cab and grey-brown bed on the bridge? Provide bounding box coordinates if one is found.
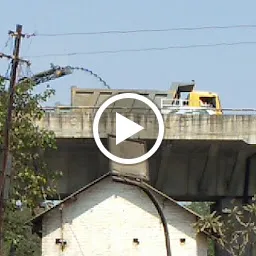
[71,81,222,115]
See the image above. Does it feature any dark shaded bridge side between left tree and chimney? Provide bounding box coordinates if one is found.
[45,139,109,194]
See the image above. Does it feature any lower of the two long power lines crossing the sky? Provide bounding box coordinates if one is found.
[25,41,256,58]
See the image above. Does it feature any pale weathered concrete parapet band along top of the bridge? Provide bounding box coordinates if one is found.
[38,110,256,144]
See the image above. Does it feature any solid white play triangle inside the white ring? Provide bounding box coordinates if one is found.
[116,113,144,145]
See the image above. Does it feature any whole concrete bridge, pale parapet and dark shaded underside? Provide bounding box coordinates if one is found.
[38,108,256,201]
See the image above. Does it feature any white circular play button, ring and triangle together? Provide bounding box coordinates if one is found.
[93,93,164,165]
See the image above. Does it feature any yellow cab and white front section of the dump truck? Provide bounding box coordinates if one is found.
[161,81,223,115]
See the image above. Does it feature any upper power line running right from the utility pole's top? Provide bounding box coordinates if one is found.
[35,24,256,37]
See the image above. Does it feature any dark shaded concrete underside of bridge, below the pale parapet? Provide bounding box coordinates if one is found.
[46,138,256,201]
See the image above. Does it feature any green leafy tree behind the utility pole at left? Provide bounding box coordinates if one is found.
[0,80,61,255]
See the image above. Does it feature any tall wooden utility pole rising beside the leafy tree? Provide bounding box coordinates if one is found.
[0,24,28,256]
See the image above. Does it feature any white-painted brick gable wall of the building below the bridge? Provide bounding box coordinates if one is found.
[42,178,207,256]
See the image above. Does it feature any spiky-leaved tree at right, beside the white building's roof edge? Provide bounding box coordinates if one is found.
[195,199,256,256]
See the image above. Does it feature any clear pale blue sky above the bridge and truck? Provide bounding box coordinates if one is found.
[0,0,256,108]
